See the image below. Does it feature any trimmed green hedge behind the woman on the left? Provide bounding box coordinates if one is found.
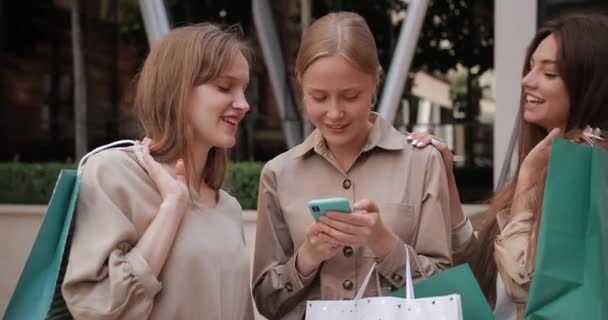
[0,162,263,209]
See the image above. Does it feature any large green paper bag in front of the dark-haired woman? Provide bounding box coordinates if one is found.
[526,139,608,320]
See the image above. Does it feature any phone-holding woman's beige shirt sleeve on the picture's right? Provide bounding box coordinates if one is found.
[376,148,452,288]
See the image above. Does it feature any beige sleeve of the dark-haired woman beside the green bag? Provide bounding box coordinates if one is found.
[494,210,534,303]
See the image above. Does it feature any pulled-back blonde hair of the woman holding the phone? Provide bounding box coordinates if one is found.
[295,12,382,83]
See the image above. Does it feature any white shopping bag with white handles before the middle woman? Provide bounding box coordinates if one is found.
[306,249,462,320]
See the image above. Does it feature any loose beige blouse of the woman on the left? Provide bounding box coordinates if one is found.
[62,149,253,320]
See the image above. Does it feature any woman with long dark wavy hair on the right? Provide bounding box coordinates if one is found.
[411,13,608,319]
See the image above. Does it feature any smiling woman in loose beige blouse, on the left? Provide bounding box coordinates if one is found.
[62,24,253,320]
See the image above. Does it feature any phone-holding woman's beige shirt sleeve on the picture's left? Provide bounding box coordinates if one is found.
[252,165,318,319]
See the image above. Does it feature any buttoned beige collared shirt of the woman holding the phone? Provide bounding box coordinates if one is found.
[253,113,452,319]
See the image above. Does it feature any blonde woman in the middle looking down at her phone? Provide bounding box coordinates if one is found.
[253,12,452,319]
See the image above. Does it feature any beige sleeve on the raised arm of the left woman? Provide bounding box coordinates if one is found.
[62,155,162,319]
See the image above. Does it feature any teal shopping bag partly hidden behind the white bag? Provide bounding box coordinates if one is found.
[391,264,494,320]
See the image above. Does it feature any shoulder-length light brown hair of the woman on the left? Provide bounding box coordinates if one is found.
[135,23,250,191]
